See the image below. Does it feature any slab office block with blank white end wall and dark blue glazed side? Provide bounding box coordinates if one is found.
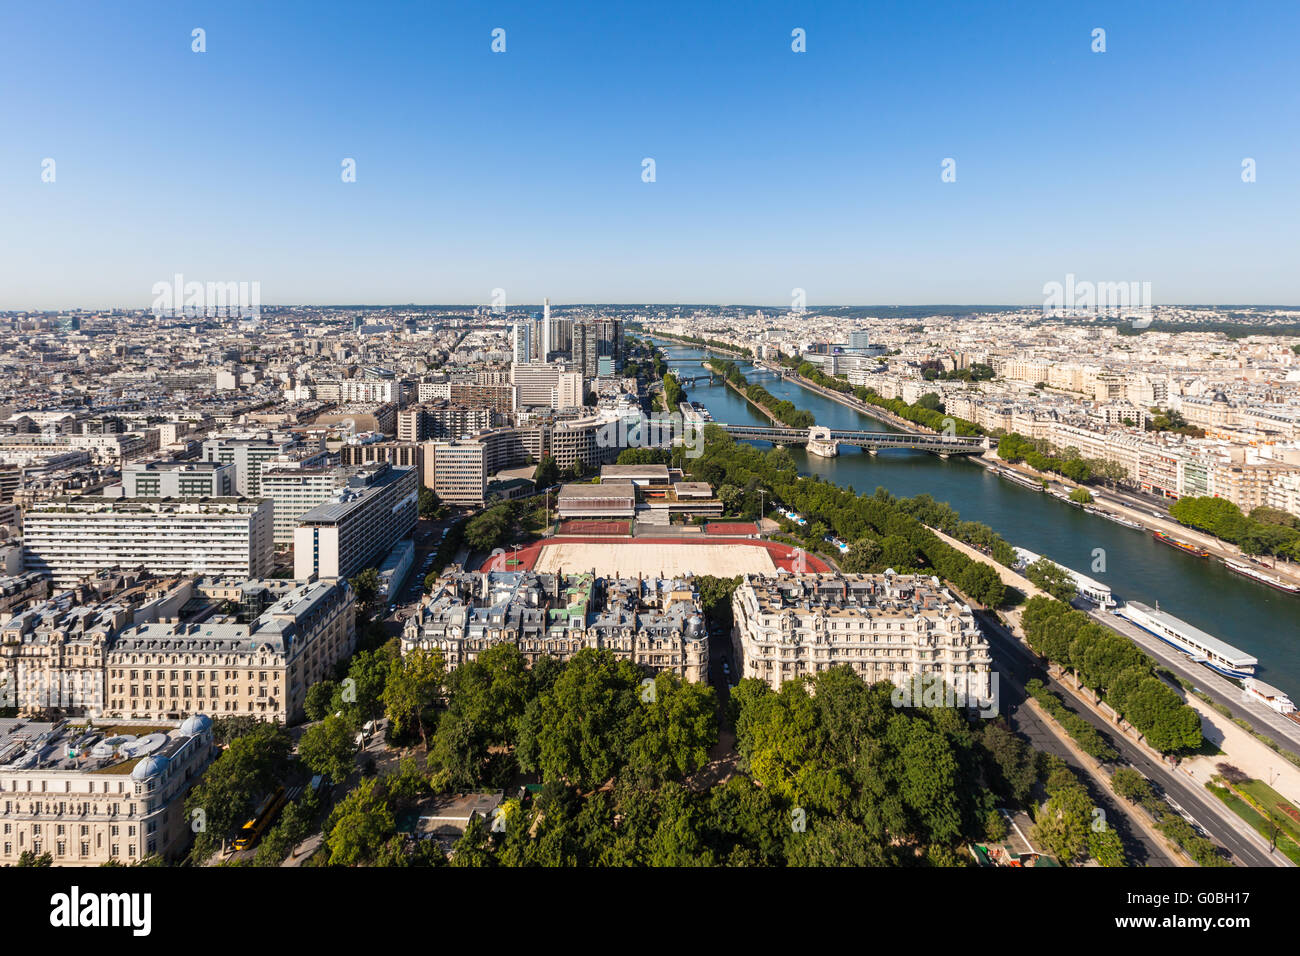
[294,462,420,580]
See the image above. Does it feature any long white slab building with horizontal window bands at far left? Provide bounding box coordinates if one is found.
[23,497,274,587]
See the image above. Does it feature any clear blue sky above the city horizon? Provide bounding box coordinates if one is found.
[0,0,1300,310]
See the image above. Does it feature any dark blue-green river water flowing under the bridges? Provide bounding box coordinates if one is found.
[653,339,1300,701]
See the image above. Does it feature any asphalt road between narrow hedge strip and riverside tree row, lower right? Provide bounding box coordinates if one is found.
[979,614,1290,866]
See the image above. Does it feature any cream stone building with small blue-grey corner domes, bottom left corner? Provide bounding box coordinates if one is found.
[0,714,218,866]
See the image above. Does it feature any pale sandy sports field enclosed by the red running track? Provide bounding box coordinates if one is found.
[534,541,776,578]
